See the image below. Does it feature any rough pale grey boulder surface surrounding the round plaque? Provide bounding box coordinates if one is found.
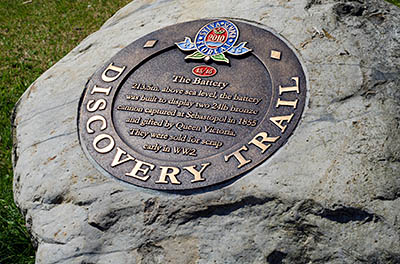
[13,0,400,264]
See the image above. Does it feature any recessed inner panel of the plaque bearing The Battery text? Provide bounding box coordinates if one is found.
[112,47,273,162]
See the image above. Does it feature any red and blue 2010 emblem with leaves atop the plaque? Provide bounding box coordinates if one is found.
[175,20,251,63]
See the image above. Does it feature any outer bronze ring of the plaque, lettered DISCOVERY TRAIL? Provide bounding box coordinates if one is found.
[77,19,308,190]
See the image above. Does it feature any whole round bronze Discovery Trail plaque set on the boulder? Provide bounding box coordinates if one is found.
[78,19,307,190]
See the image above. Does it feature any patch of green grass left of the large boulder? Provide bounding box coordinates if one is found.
[0,0,131,264]
